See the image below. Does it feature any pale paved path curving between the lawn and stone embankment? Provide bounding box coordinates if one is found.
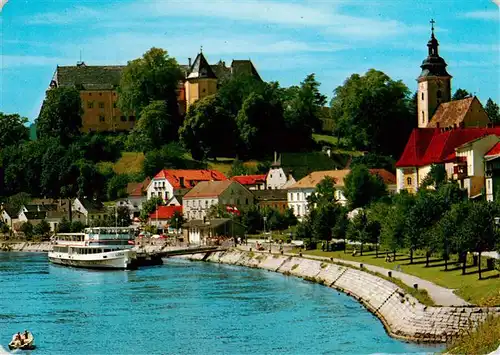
[240,246,470,306]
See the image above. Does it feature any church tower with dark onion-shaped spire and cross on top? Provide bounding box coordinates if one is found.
[417,20,452,128]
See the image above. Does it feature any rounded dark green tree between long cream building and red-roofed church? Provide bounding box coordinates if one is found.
[344,165,387,209]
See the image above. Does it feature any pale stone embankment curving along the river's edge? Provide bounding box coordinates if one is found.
[181,249,500,343]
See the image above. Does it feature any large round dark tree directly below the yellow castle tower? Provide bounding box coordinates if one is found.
[179,95,237,160]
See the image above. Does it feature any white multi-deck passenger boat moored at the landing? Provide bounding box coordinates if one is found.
[49,227,137,269]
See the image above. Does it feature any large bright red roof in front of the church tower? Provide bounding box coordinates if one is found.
[396,127,500,167]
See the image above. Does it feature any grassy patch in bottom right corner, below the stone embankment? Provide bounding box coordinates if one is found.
[446,317,500,354]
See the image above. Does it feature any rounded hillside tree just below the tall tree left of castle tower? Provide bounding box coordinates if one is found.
[127,101,180,153]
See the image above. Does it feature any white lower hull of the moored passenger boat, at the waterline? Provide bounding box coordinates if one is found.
[48,250,137,270]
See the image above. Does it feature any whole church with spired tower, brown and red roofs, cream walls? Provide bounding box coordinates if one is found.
[396,21,494,196]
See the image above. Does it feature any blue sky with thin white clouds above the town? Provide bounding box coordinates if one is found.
[0,0,500,120]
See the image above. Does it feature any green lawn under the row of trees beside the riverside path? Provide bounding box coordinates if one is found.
[304,250,500,306]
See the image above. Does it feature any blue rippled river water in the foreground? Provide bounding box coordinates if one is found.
[0,252,443,355]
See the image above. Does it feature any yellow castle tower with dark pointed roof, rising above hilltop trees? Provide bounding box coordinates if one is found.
[184,50,217,108]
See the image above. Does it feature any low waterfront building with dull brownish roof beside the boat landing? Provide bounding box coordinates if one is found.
[182,218,245,245]
